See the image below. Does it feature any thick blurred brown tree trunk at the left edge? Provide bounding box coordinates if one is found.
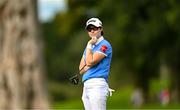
[0,0,49,109]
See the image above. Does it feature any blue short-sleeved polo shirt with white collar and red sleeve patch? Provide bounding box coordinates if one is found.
[82,37,112,82]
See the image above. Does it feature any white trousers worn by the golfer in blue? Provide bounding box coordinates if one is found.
[82,78,109,110]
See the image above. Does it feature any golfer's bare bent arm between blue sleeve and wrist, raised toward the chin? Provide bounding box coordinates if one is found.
[86,48,105,67]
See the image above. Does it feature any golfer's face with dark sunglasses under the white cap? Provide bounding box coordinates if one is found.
[87,26,101,37]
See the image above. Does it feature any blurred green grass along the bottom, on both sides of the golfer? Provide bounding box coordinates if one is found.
[53,86,180,110]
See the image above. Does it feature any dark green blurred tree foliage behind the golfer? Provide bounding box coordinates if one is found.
[43,0,180,103]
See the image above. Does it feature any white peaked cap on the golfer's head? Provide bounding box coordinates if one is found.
[85,18,102,29]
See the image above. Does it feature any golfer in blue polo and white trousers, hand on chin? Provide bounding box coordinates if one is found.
[79,18,112,110]
